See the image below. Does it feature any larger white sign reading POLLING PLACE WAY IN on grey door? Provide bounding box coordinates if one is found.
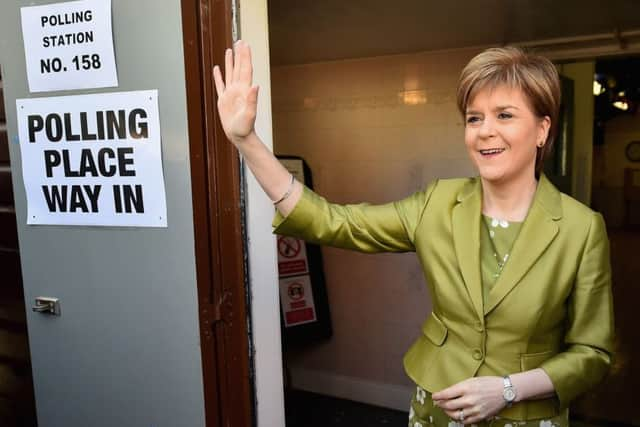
[16,90,167,227]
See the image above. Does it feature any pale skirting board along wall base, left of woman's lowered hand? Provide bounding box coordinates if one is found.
[290,367,414,412]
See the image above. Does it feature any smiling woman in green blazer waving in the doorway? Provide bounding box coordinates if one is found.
[214,42,613,427]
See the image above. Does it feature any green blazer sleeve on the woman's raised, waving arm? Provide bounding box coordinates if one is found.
[273,181,437,253]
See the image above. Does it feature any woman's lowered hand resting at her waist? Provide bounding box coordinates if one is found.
[431,377,506,424]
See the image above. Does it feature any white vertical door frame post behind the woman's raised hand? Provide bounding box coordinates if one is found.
[239,0,285,427]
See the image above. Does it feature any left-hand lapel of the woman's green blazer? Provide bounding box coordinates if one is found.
[452,178,484,319]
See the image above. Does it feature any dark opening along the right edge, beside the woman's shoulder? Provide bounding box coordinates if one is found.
[581,56,640,425]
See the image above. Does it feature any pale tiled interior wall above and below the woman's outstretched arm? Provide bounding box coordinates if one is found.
[272,49,477,411]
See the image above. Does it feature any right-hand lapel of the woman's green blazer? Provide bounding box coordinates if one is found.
[484,175,562,315]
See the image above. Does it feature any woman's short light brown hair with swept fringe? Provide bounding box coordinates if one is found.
[457,46,560,175]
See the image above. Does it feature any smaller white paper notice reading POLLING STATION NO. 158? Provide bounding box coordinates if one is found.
[20,0,118,92]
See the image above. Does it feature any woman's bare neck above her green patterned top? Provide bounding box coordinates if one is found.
[480,177,538,222]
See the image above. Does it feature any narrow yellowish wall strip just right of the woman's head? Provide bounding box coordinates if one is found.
[558,61,595,206]
